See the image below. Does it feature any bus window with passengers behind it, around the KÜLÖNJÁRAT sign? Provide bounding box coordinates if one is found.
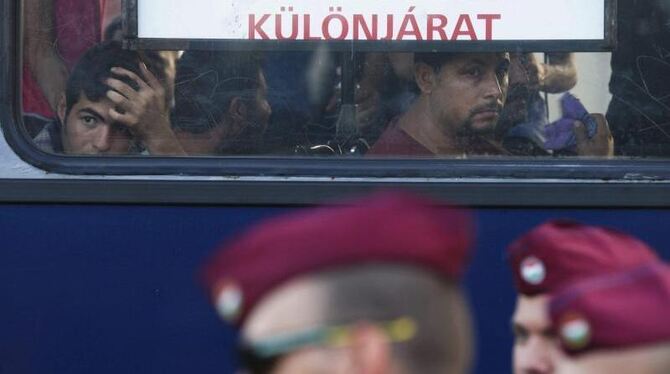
[22,0,670,159]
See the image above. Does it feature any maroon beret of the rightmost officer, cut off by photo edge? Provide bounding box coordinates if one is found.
[550,262,670,355]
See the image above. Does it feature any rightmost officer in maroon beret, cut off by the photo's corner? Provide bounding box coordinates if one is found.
[551,262,670,374]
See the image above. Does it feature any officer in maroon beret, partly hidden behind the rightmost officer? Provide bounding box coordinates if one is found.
[508,221,658,374]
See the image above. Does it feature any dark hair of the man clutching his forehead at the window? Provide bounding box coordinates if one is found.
[65,41,165,117]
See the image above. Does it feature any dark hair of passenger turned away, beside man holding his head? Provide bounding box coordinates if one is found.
[172,51,262,133]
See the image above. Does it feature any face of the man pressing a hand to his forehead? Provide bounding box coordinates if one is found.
[59,92,131,155]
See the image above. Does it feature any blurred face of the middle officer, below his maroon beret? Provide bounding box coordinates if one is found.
[512,295,563,374]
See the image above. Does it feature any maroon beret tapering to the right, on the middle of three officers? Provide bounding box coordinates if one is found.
[508,220,658,296]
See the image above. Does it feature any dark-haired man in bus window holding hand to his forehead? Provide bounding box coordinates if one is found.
[34,42,183,155]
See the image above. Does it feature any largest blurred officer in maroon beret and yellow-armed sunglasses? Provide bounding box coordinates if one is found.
[204,193,473,374]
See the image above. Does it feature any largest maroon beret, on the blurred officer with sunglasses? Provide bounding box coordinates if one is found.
[203,192,473,325]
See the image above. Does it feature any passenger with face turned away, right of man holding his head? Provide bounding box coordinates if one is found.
[172,51,272,155]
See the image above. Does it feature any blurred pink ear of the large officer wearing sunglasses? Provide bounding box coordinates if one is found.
[350,323,392,374]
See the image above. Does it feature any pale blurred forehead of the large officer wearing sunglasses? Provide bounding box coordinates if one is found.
[242,276,328,341]
